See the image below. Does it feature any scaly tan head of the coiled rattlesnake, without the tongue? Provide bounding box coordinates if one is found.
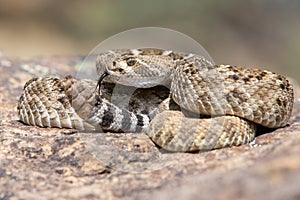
[96,49,173,88]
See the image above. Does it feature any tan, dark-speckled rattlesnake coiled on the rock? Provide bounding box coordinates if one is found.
[18,49,294,151]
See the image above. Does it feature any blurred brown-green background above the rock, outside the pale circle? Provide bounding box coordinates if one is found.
[0,0,300,81]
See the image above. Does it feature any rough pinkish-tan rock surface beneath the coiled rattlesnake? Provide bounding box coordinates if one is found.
[0,57,300,199]
